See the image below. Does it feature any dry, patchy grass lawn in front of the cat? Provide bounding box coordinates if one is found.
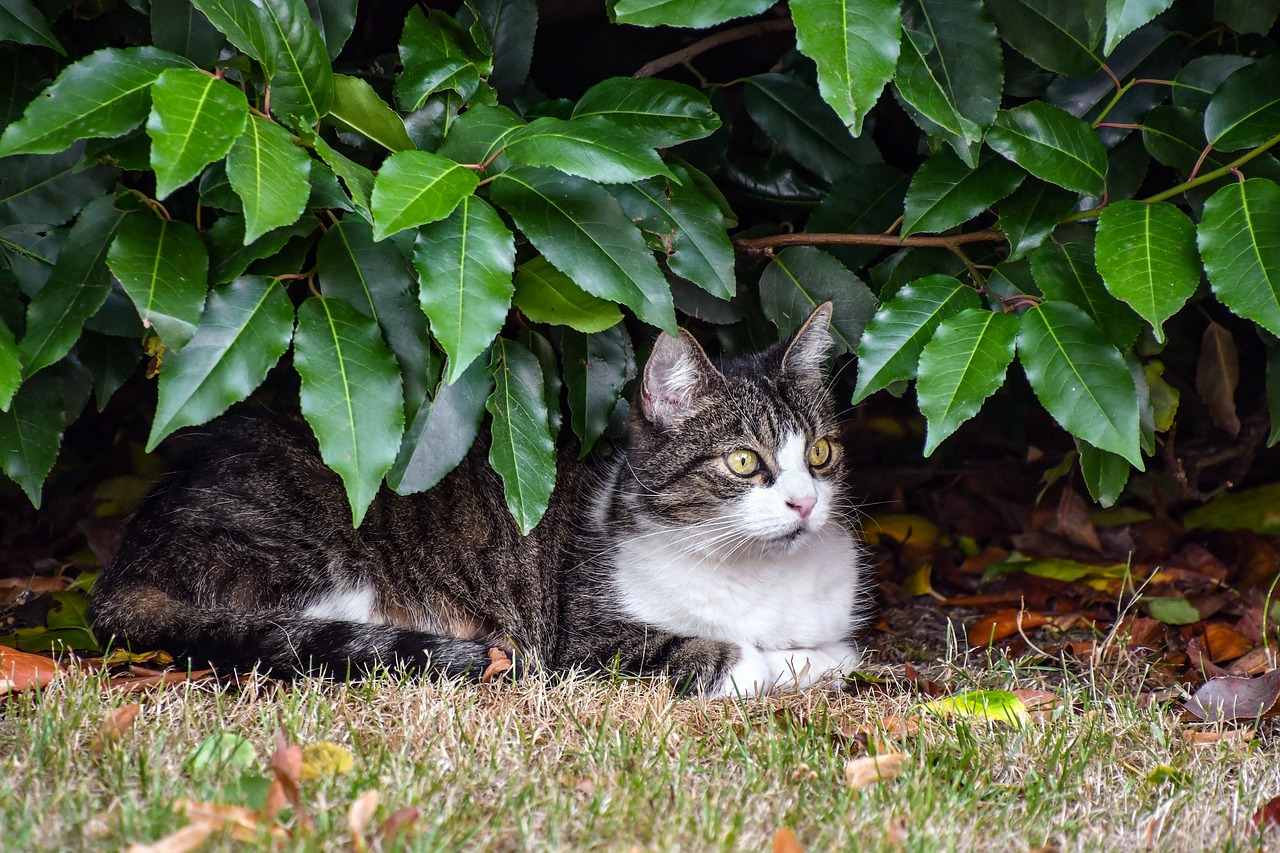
[0,648,1280,850]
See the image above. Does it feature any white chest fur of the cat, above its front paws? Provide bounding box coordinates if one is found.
[614,524,859,649]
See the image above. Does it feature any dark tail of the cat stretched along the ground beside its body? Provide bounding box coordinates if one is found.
[92,584,499,680]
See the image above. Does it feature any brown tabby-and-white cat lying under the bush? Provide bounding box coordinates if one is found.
[92,304,867,697]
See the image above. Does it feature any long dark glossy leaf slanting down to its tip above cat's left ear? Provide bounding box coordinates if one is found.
[492,167,677,333]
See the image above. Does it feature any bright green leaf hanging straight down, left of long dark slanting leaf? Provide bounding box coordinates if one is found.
[413,196,516,383]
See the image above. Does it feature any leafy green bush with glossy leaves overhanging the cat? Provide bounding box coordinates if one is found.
[0,0,1280,530]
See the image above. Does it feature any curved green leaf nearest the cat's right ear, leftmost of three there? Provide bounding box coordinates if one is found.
[854,275,980,403]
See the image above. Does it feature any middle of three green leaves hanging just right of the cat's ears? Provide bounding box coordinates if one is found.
[915,309,1018,456]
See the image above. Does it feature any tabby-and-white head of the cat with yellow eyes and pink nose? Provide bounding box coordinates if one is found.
[620,302,844,557]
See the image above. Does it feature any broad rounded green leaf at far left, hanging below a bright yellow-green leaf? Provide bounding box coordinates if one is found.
[106,214,209,350]
